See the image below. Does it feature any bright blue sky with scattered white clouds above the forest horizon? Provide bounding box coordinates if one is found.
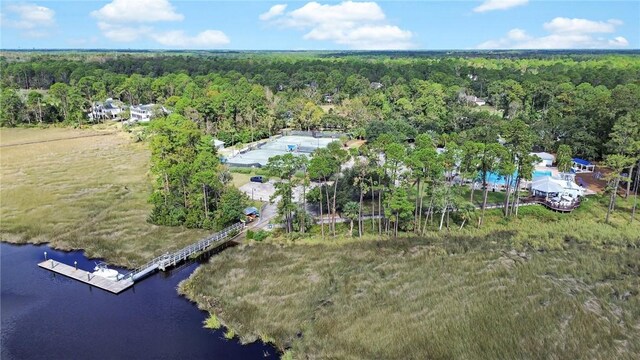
[0,0,640,50]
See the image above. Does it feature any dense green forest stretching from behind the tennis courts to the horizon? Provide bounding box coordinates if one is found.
[0,52,640,159]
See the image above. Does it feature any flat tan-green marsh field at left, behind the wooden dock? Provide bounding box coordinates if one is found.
[0,128,205,266]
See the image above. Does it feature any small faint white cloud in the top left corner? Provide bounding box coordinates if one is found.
[2,3,56,37]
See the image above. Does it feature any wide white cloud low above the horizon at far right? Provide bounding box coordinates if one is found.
[477,17,629,49]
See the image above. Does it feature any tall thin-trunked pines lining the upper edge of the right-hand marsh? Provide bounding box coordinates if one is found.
[266,110,640,237]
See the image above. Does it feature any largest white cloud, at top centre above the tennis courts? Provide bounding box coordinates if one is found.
[261,1,414,50]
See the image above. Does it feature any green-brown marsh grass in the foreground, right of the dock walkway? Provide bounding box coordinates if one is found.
[180,198,640,359]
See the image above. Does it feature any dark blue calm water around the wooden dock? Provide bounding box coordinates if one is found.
[0,243,277,360]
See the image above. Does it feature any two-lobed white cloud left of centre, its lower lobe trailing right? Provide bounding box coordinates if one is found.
[91,0,229,49]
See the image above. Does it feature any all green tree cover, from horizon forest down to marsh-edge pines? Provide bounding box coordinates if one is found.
[0,52,640,234]
